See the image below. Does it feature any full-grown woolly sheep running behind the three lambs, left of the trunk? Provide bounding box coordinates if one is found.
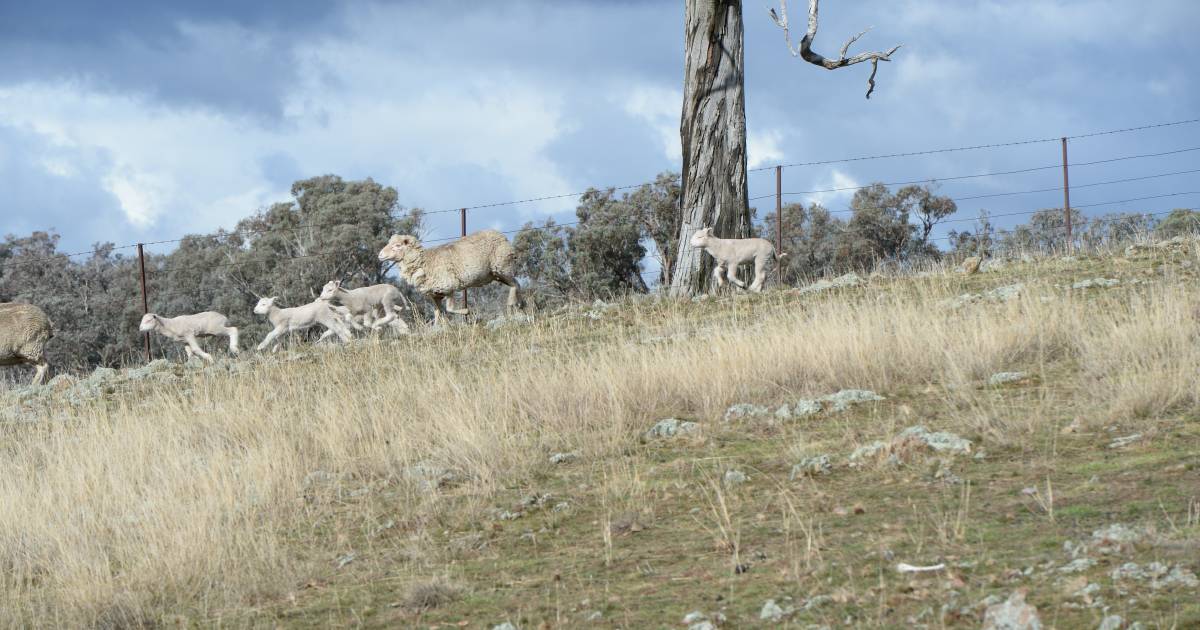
[379,229,521,325]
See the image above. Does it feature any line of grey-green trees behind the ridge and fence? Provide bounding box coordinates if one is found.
[0,173,1200,370]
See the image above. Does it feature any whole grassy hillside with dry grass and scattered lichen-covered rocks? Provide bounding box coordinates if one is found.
[0,241,1200,629]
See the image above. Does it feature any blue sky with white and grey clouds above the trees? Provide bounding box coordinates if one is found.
[0,0,1200,259]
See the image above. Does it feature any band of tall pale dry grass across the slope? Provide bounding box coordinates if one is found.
[0,268,1200,625]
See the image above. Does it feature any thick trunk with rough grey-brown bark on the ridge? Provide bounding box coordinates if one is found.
[671,0,750,295]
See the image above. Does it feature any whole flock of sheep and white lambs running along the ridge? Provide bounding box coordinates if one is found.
[0,228,784,384]
